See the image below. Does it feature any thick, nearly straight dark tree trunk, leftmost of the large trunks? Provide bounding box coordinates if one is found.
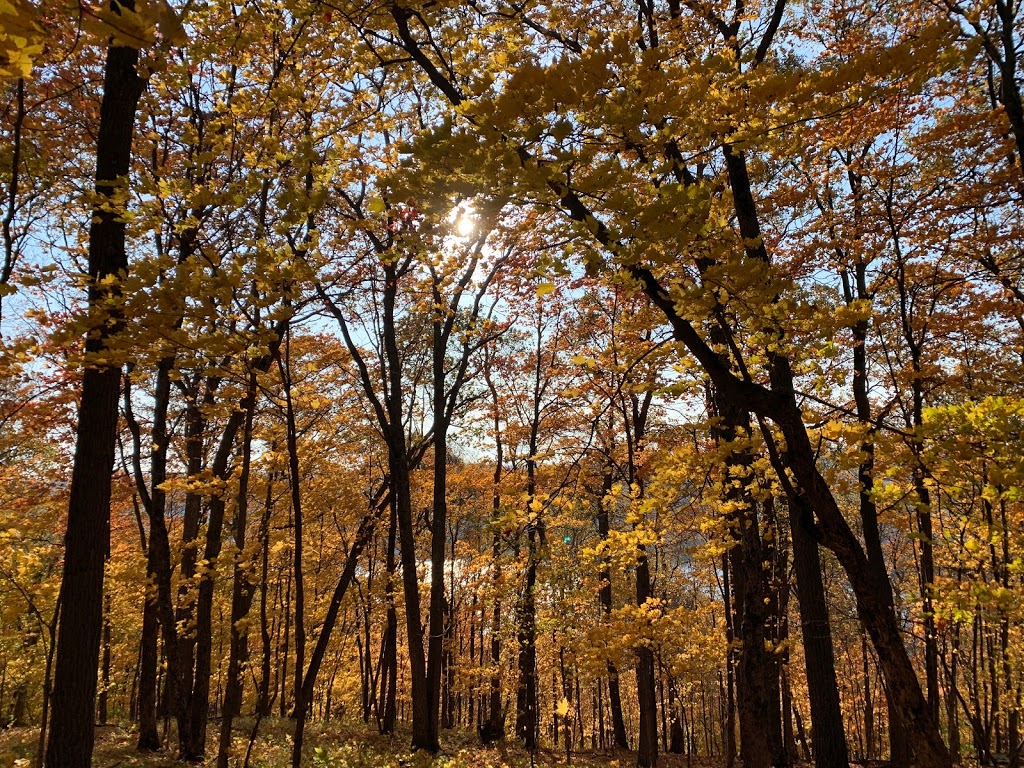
[46,33,145,768]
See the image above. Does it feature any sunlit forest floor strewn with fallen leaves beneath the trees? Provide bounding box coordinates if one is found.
[0,719,737,768]
